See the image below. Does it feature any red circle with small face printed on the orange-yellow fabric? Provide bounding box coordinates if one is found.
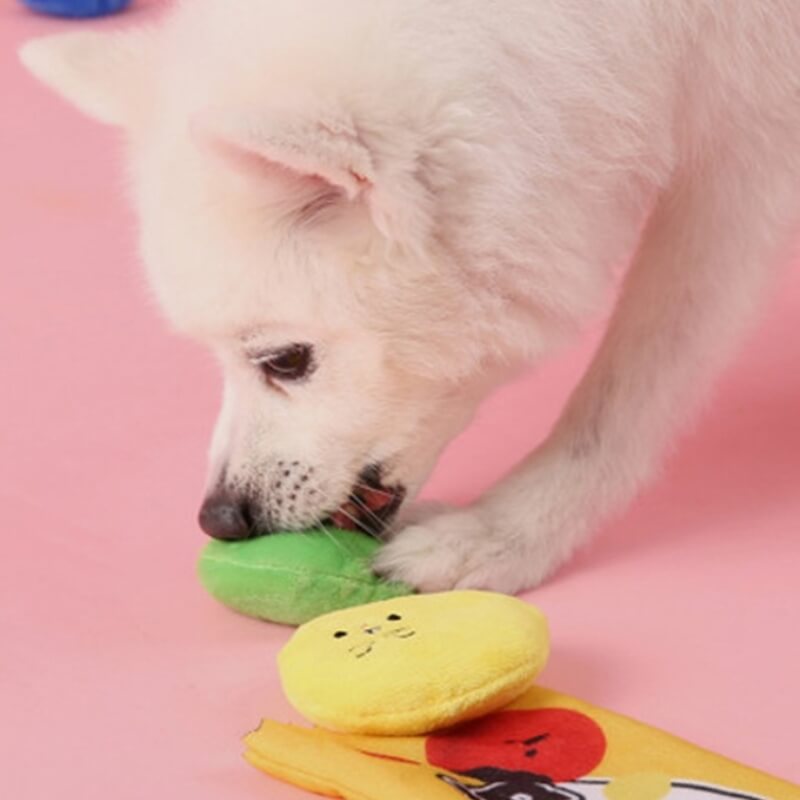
[425,708,606,782]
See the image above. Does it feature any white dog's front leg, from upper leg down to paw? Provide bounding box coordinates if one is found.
[376,156,797,592]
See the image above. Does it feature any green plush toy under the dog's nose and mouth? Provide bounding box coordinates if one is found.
[198,528,413,625]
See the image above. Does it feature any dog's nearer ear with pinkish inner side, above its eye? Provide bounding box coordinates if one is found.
[190,110,431,248]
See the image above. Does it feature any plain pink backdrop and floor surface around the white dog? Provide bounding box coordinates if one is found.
[0,0,800,800]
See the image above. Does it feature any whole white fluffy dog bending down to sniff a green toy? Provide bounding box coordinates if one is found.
[22,0,800,592]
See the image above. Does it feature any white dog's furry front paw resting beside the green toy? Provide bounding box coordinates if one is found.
[373,509,544,594]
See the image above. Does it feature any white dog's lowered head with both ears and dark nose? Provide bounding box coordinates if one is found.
[22,9,552,538]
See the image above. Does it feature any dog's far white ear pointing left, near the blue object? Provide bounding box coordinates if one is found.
[19,28,155,126]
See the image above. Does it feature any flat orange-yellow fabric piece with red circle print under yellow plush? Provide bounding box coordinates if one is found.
[245,687,800,800]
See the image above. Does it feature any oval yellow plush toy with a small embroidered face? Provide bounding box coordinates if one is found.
[278,591,549,735]
